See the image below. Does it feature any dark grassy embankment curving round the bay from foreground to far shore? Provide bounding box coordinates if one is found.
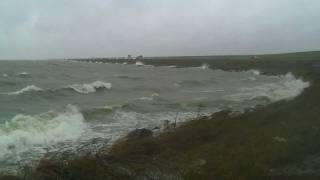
[2,52,320,180]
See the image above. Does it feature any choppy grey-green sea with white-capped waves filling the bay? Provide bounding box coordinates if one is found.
[0,60,309,173]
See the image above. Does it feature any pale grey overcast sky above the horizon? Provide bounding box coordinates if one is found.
[0,0,320,59]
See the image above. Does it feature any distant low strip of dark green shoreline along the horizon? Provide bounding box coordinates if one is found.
[72,51,320,76]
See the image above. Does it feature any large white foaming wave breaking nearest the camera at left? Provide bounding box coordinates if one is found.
[0,105,86,159]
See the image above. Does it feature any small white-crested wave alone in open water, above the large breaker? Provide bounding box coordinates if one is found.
[69,81,112,94]
